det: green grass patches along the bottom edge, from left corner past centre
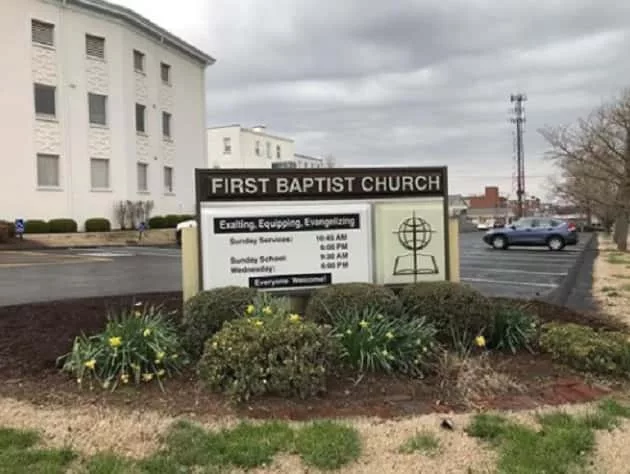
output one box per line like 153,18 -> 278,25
0,421 -> 361,474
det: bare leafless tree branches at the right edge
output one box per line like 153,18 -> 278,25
540,90 -> 630,251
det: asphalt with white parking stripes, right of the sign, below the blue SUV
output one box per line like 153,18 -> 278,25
460,232 -> 588,298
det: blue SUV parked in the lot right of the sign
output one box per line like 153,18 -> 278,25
482,217 -> 579,250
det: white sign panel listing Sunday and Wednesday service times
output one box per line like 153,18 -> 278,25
200,203 -> 372,291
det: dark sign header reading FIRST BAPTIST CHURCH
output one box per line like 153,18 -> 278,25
195,167 -> 448,202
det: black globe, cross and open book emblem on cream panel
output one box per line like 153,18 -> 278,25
393,211 -> 439,281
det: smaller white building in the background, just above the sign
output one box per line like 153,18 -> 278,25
207,124 -> 324,168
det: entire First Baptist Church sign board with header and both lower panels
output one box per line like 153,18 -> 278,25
195,167 -> 449,292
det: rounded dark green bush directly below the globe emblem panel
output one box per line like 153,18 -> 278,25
399,281 -> 495,353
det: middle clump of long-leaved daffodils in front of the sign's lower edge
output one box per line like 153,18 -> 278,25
332,307 -> 436,376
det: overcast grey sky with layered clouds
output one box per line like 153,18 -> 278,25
115,0 -> 630,197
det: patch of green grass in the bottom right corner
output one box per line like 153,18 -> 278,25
466,400 -> 630,474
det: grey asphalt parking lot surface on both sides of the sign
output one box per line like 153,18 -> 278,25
0,232 -> 586,306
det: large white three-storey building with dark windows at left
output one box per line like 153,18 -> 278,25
0,0 -> 215,227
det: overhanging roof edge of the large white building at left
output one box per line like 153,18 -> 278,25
64,0 -> 216,66
